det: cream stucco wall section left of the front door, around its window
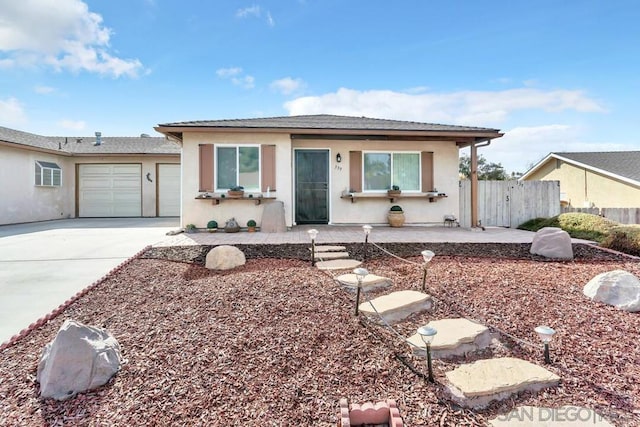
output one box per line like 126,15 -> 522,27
182,132 -> 293,228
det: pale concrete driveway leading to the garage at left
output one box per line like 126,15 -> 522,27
0,218 -> 179,343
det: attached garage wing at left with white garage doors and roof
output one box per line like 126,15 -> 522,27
0,127 -> 180,224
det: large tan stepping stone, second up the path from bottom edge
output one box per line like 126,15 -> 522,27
446,357 -> 560,409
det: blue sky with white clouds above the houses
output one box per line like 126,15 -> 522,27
0,0 -> 640,172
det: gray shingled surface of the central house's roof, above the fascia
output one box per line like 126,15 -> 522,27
159,114 -> 498,133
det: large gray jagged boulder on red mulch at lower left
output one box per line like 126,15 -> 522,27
36,320 -> 122,400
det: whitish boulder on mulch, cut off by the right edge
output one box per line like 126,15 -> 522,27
582,270 -> 640,312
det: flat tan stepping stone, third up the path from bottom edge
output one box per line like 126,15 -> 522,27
407,319 -> 491,359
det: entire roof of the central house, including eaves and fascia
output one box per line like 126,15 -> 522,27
155,114 -> 502,148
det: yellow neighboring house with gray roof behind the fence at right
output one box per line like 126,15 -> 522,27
520,151 -> 640,208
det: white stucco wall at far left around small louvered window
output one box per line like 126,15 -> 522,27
0,146 -> 75,224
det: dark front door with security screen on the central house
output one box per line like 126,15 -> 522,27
295,150 -> 329,224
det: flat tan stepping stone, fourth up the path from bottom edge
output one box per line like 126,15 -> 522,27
358,291 -> 432,324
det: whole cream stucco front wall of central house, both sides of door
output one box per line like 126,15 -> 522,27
182,132 -> 459,228
